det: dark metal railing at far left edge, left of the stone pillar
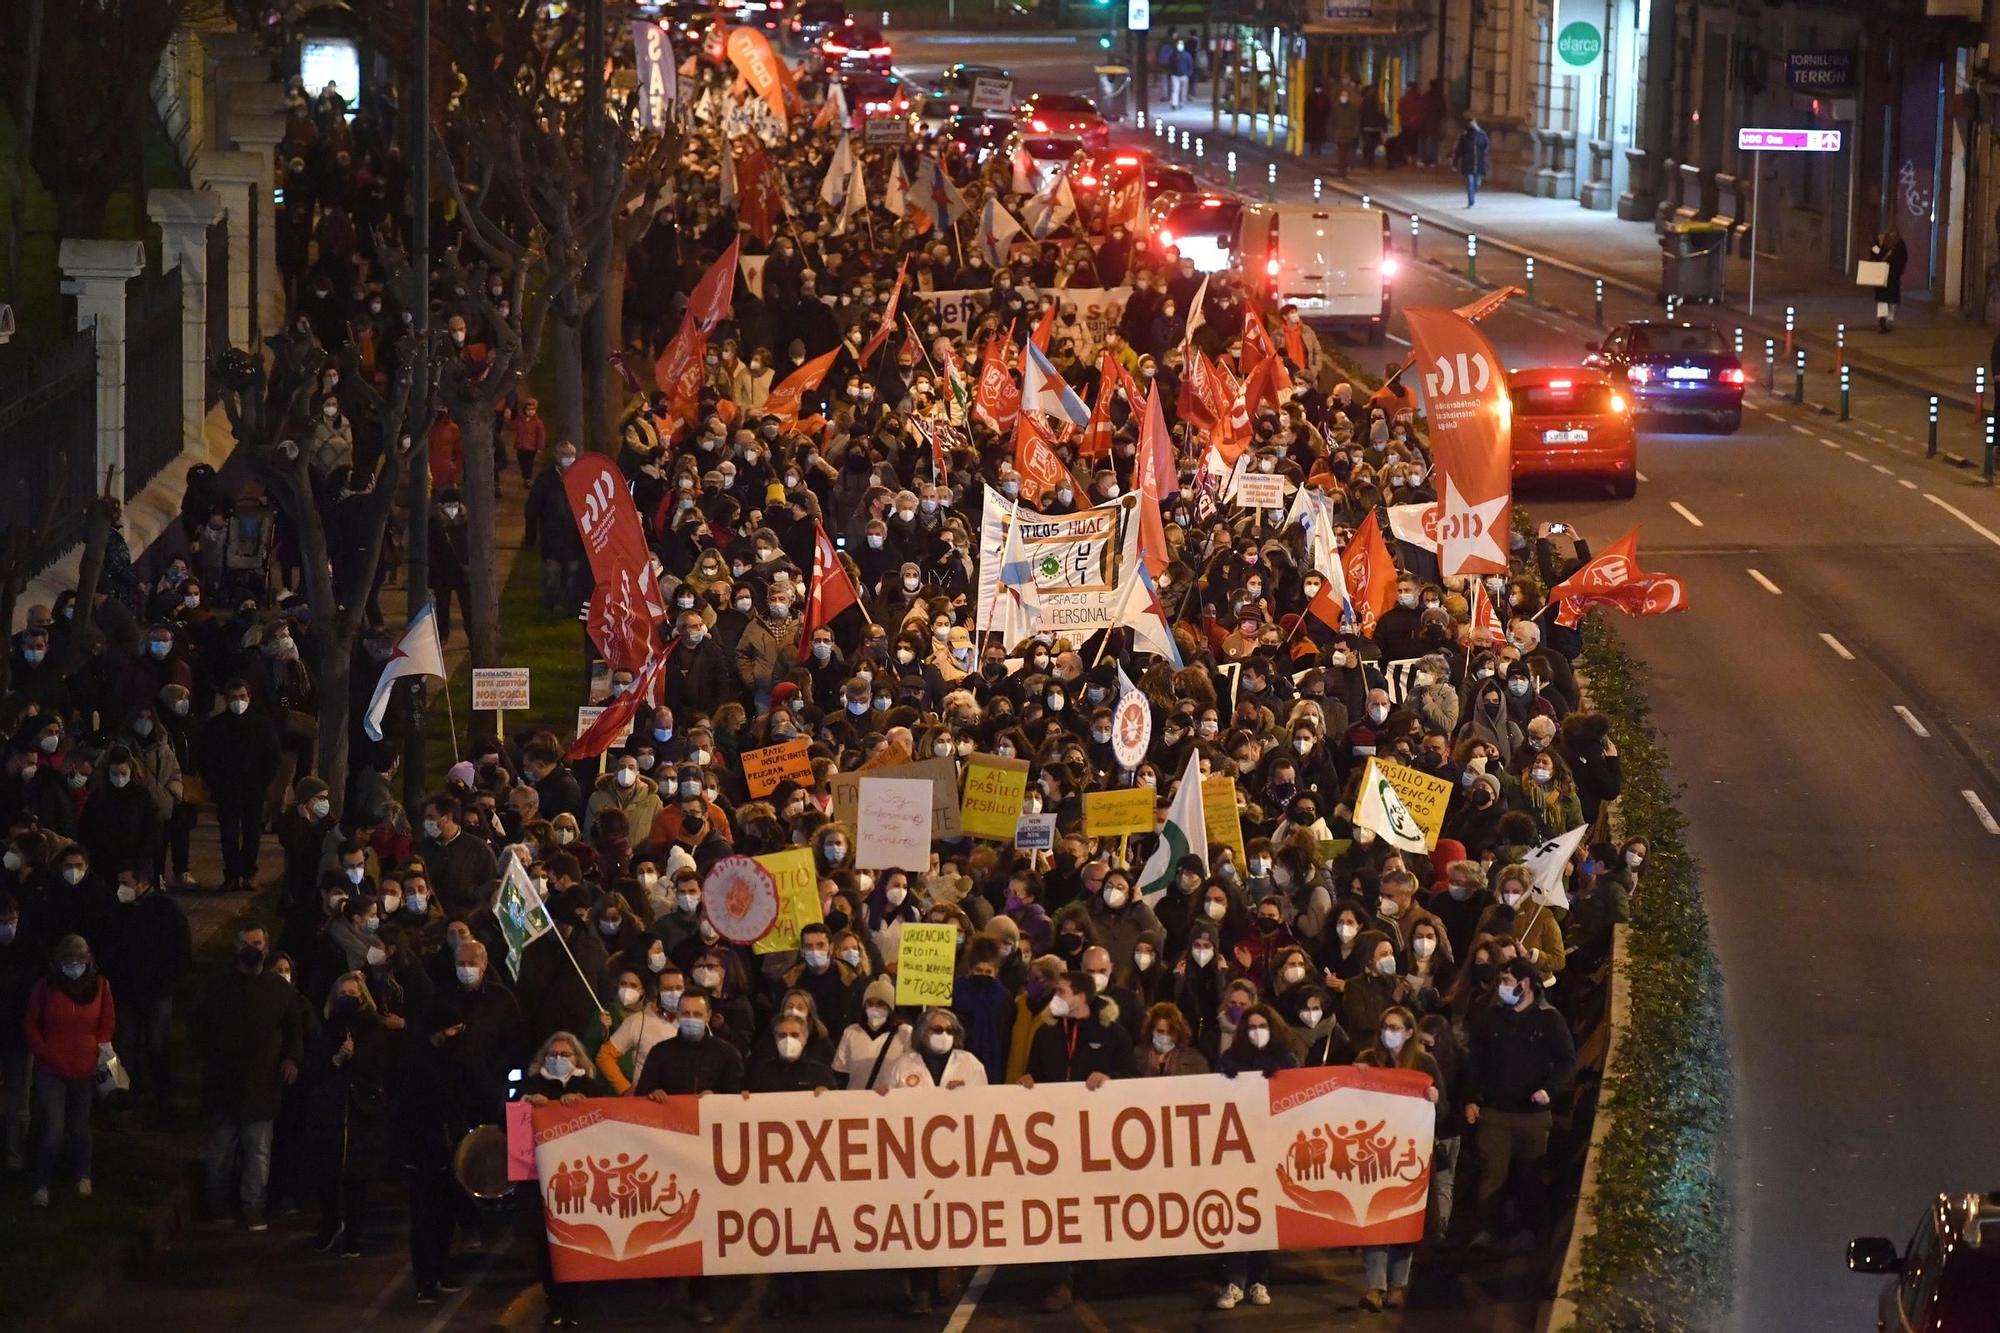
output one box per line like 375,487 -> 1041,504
0,328 -> 100,578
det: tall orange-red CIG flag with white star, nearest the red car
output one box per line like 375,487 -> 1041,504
1404,306 -> 1514,574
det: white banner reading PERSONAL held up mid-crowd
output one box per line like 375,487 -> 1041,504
976,490 -> 1138,648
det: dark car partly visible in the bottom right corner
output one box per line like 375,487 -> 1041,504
1848,1191 -> 2000,1333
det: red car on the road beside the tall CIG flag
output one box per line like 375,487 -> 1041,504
1508,366 -> 1638,498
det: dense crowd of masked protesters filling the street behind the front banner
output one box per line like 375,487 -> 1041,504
0,26 -> 1646,1323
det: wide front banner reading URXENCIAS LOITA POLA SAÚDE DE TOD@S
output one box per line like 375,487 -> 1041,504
532,1049 -> 1434,1281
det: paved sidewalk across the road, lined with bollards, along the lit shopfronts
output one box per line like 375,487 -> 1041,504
1146,102 -> 1994,408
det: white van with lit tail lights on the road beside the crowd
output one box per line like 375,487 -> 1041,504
1234,202 -> 1396,342
